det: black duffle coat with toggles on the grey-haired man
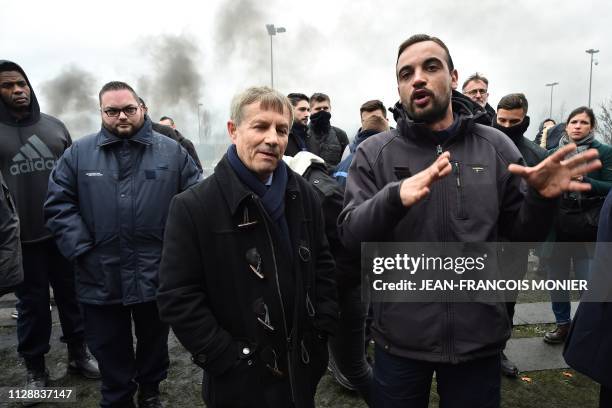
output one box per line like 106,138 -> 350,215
157,155 -> 338,408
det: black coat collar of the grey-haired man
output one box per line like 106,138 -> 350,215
214,153 -> 300,214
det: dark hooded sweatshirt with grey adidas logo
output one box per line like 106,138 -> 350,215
0,60 -> 72,244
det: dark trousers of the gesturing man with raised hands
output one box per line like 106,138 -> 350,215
374,345 -> 501,408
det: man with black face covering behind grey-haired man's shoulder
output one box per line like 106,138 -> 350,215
308,93 -> 348,166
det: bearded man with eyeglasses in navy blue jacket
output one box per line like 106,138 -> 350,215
45,82 -> 200,408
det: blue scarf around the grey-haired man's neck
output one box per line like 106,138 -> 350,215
227,144 -> 291,255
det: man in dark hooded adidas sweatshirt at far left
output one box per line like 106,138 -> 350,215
0,60 -> 100,388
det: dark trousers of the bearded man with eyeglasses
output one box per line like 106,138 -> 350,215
82,302 -> 170,407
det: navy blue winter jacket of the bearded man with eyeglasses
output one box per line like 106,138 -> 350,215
45,119 -> 200,305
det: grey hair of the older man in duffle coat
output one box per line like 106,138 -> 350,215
230,86 -> 293,126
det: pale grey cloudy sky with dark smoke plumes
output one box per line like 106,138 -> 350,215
0,0 -> 612,152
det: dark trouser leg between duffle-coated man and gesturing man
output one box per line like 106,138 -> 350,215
329,286 -> 372,405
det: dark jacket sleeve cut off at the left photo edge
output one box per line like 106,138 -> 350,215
0,173 -> 23,296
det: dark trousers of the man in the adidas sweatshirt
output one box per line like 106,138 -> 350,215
15,239 -> 84,361
